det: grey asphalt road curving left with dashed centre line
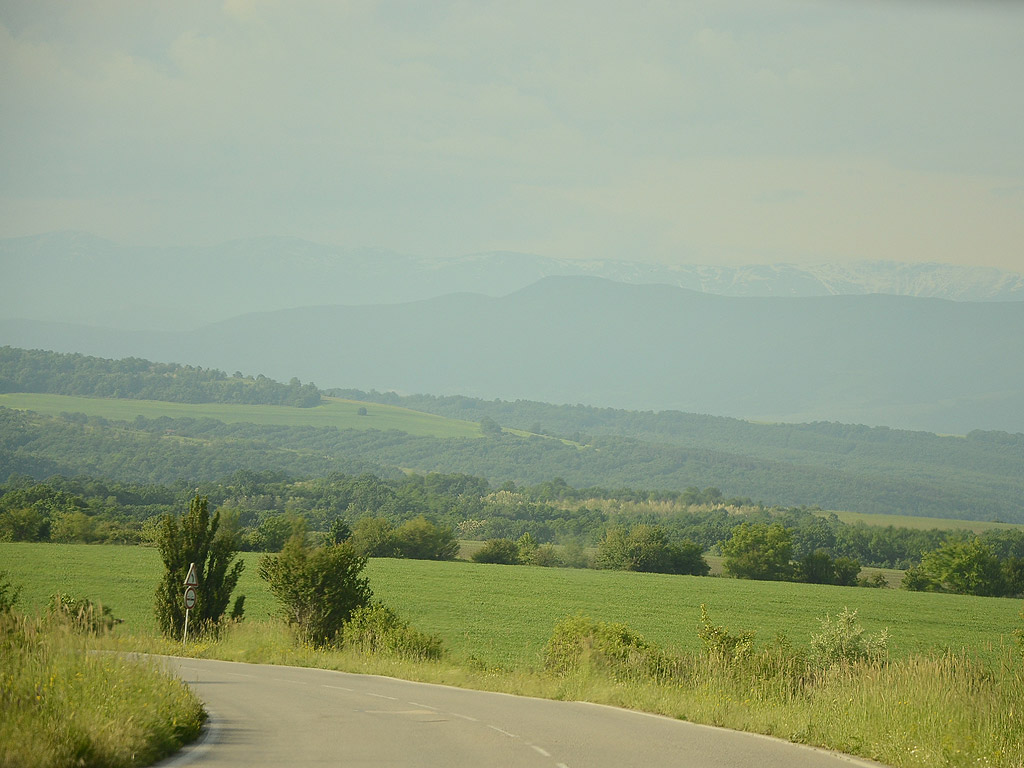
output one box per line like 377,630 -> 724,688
155,658 -> 878,768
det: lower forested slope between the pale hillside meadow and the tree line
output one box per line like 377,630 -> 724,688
0,409 -> 1024,522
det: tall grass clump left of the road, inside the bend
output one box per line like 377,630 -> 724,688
0,611 -> 205,768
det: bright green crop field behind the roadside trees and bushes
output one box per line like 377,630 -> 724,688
0,544 -> 1021,667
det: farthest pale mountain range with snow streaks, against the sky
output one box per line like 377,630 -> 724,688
0,232 -> 1024,331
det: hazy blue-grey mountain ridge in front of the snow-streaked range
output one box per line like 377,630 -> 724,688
0,275 -> 1024,433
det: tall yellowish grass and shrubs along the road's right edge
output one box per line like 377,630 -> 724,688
546,613 -> 1024,768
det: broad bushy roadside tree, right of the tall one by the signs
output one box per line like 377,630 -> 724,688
259,534 -> 373,645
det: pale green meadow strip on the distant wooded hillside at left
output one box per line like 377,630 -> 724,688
0,392 -> 482,437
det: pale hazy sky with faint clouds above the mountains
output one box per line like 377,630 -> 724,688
0,0 -> 1024,271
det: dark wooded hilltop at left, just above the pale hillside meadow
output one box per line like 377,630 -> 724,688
0,346 -> 321,408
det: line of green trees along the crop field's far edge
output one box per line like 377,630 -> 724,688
0,471 -> 1024,595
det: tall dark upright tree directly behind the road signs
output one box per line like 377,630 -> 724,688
154,496 -> 245,638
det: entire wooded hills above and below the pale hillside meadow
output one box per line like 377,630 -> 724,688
0,348 -> 1024,522
